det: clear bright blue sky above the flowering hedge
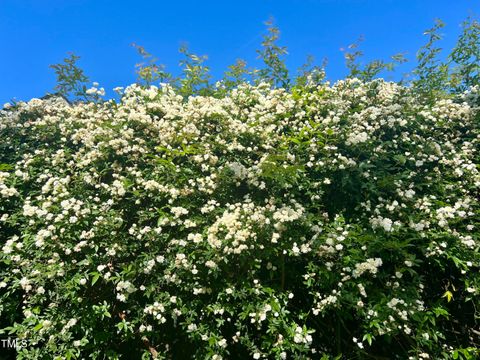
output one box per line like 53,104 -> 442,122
0,0 -> 480,104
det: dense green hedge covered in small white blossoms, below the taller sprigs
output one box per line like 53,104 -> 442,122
0,79 -> 480,360
